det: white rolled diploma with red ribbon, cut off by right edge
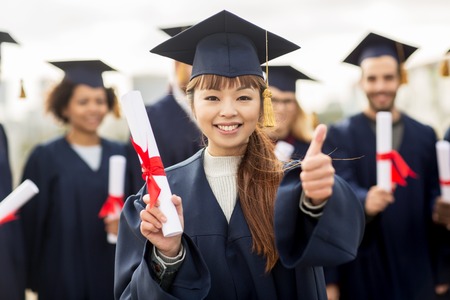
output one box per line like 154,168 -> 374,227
436,141 -> 450,203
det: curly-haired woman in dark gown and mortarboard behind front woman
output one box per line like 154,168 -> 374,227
20,60 -> 129,300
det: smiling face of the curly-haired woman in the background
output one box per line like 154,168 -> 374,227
63,84 -> 109,134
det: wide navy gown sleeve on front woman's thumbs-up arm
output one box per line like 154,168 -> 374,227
275,168 -> 365,268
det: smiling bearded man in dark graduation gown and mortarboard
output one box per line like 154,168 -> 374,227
325,33 -> 448,300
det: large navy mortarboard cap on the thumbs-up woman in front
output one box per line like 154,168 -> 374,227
150,10 -> 300,79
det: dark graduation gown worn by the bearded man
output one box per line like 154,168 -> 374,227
324,113 -> 439,300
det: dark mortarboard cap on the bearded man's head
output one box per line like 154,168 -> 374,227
344,32 -> 418,66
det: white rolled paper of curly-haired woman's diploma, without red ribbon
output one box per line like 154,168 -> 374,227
107,155 -> 126,244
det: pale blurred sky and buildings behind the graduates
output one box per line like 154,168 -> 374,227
0,0 -> 450,190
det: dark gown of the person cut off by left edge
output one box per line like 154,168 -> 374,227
0,124 -> 25,300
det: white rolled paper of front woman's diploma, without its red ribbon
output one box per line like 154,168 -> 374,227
121,91 -> 183,237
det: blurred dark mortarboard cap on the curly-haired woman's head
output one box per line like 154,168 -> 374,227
50,60 -> 116,87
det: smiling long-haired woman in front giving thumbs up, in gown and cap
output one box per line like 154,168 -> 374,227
115,11 -> 364,300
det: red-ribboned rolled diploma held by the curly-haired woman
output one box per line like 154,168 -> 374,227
98,155 -> 126,244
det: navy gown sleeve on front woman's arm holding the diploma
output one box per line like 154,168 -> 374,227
114,186 -> 210,300
